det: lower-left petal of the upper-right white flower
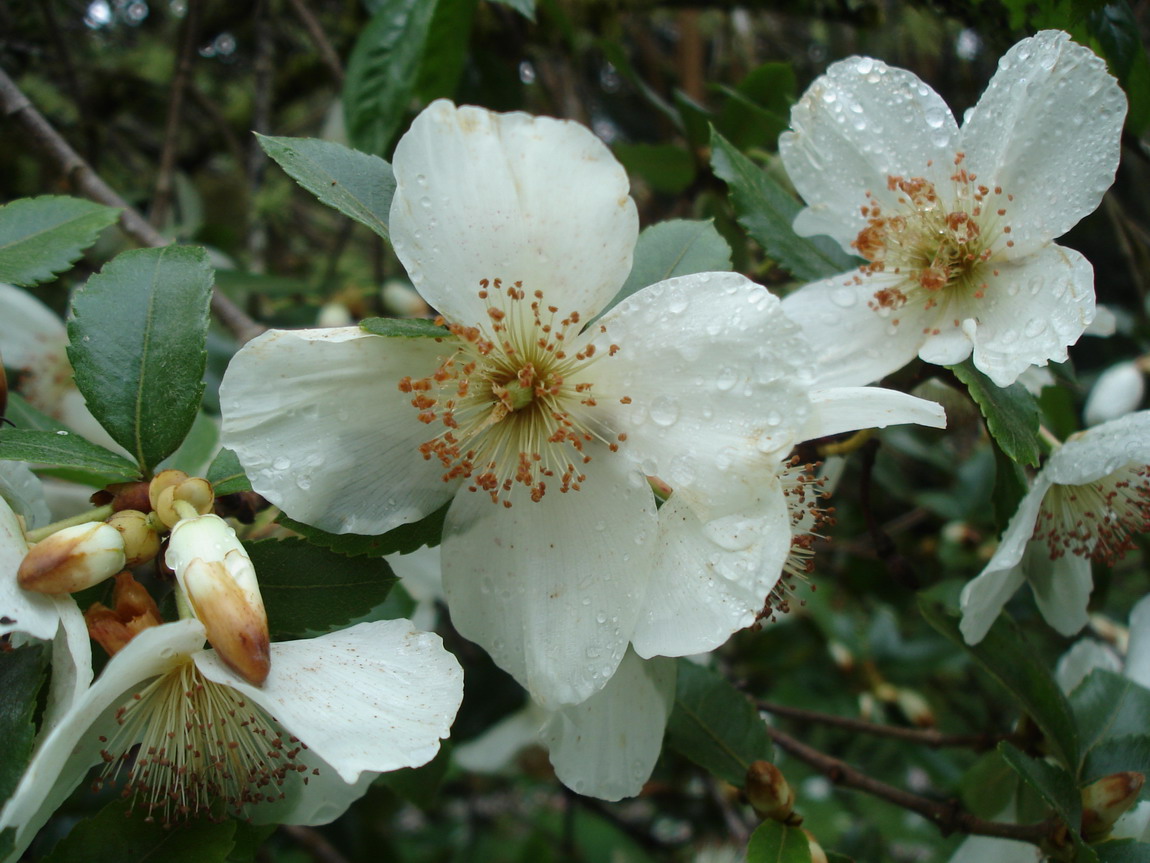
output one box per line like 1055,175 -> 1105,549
783,273 -> 925,387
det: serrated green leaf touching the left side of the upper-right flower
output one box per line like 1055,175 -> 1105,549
711,130 -> 859,282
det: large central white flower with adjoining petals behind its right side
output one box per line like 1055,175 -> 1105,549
221,101 -> 942,709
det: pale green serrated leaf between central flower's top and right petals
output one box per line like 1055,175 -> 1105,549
604,219 -> 730,312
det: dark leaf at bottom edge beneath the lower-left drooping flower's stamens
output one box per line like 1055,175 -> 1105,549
44,800 -> 236,863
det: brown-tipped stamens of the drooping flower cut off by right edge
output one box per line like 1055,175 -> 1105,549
1033,464 -> 1150,564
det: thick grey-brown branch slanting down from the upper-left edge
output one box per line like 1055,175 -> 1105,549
0,63 -> 265,344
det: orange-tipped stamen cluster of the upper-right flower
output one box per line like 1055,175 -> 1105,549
851,153 -> 1014,335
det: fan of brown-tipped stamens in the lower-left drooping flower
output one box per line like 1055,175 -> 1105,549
95,657 -> 314,825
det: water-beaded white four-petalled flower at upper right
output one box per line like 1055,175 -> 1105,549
779,30 -> 1126,387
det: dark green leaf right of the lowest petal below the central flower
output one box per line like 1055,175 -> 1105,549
667,659 -> 773,787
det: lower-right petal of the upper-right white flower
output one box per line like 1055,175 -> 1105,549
971,245 -> 1095,387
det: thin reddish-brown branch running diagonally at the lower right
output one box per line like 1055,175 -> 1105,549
766,725 -> 1063,845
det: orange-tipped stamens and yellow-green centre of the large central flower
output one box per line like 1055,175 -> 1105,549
399,278 -> 630,506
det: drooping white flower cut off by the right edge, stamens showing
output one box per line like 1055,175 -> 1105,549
961,411 -> 1150,644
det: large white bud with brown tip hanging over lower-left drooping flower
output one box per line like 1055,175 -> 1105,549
164,515 -> 271,686
